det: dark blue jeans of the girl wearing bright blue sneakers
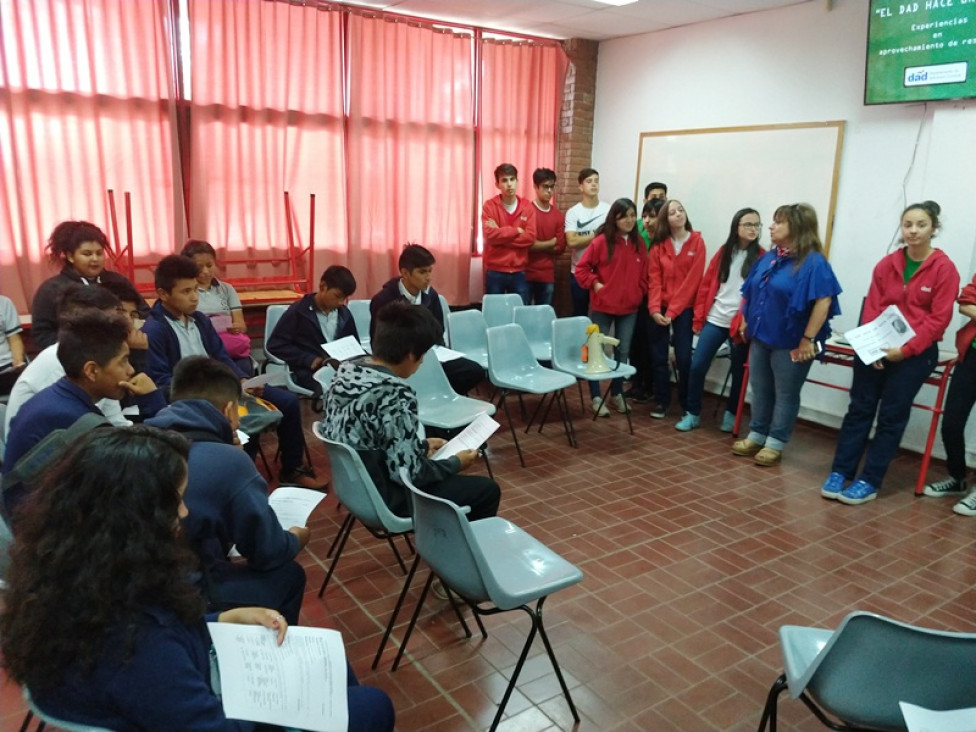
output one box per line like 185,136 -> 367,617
831,344 -> 936,488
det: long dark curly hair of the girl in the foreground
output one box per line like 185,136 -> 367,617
0,426 -> 204,688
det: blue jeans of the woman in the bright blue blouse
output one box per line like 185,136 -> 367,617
749,339 -> 813,450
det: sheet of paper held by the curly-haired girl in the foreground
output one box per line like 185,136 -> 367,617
207,623 -> 349,732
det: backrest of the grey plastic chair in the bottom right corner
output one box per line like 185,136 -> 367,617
790,612 -> 976,729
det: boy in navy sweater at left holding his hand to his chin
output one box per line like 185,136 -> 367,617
3,309 -> 162,516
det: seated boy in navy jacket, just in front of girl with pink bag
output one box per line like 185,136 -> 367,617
144,254 -> 328,490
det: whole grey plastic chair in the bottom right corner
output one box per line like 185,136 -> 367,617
760,612 -> 976,732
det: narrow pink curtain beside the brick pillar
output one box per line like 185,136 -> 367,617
479,39 -> 567,249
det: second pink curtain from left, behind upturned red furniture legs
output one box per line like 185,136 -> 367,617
186,0 -> 348,282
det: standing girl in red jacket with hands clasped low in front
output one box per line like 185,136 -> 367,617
647,199 -> 705,419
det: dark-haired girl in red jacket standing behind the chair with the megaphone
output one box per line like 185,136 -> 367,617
574,198 -> 647,417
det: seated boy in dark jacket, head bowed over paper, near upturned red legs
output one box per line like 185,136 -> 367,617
264,264 -> 359,396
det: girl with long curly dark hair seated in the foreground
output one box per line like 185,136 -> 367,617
0,425 -> 395,732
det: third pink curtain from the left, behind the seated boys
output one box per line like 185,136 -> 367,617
346,12 -> 475,303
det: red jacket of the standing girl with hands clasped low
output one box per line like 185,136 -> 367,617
647,231 -> 705,319
